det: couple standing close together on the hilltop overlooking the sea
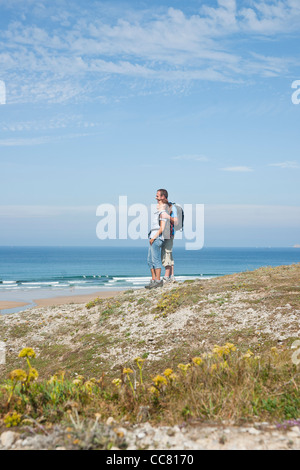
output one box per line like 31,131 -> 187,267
145,189 -> 178,289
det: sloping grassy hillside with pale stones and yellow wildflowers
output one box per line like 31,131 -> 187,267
0,264 -> 300,432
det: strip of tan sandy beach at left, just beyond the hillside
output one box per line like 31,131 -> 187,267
0,291 -> 120,310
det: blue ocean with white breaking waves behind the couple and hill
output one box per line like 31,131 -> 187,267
0,246 -> 300,313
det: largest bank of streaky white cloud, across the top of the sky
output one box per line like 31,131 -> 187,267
0,0 -> 300,103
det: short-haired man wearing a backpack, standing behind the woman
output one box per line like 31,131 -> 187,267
158,189 -> 178,282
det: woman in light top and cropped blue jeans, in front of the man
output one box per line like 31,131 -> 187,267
145,197 -> 169,289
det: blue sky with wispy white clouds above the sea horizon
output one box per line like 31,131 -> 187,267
0,0 -> 300,247
